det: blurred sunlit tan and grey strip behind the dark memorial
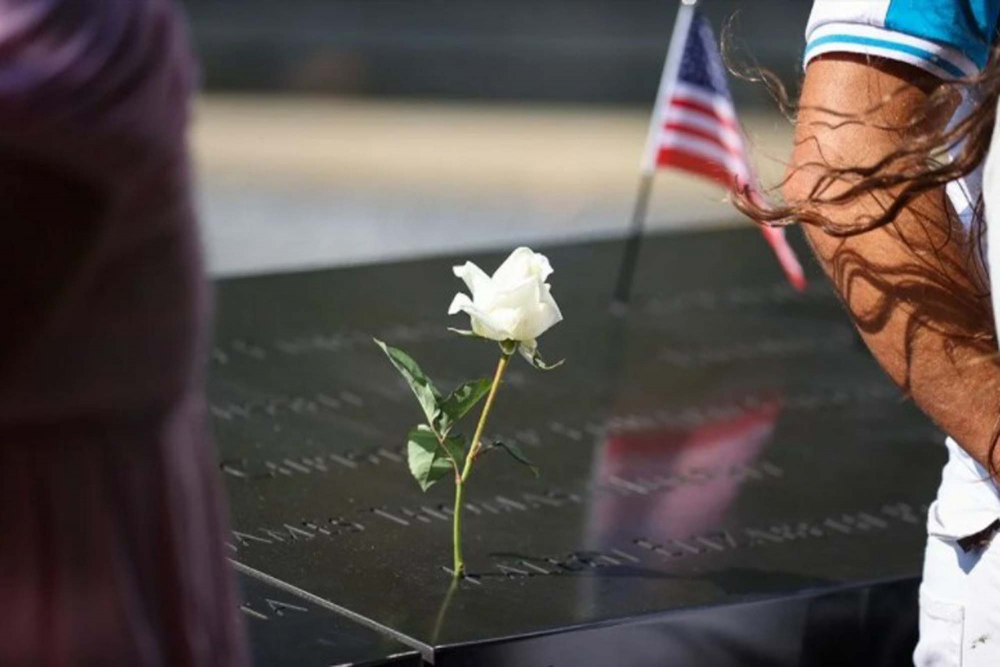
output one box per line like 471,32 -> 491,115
193,96 -> 790,275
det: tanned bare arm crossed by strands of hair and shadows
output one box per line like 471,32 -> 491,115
784,55 -> 1000,467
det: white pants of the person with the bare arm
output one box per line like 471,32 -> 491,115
913,441 -> 1000,667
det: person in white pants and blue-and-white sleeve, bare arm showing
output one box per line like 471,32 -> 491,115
737,0 -> 1000,667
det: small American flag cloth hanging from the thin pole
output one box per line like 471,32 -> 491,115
643,2 -> 805,289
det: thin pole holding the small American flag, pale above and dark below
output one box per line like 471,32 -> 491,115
612,0 -> 698,310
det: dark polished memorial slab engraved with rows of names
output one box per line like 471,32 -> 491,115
210,230 -> 943,666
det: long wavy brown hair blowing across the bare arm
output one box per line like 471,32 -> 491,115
723,36 -> 1000,478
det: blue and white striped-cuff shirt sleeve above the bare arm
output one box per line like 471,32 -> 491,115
805,0 -> 1000,79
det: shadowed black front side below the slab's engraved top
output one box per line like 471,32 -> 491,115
434,581 -> 917,667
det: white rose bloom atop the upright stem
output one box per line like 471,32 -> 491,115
448,248 -> 562,356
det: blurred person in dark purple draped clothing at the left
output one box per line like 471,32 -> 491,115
0,0 -> 247,667
